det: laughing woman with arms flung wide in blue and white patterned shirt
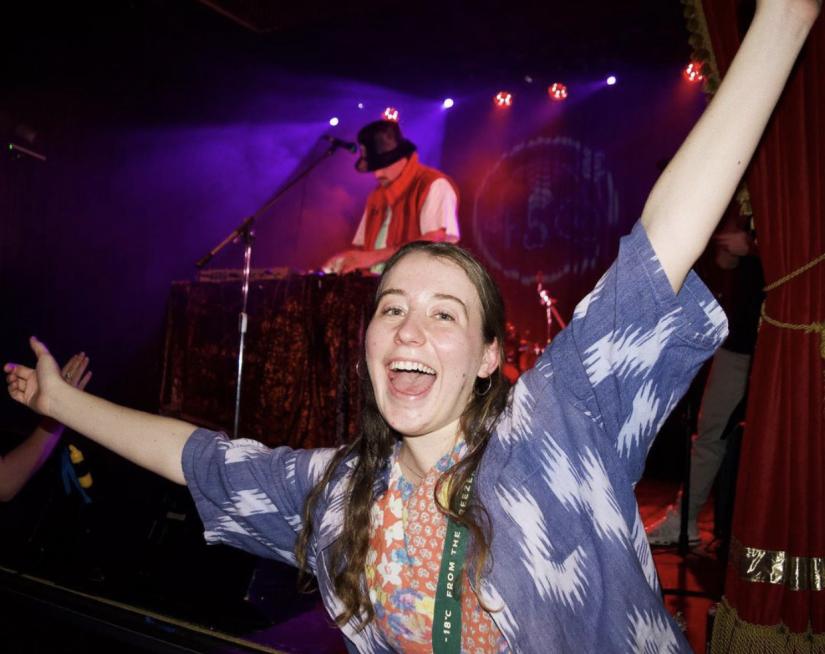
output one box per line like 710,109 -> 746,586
5,0 -> 820,653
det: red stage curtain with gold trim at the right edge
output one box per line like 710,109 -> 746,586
688,0 -> 825,652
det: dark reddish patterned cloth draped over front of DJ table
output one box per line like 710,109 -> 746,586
161,275 -> 378,447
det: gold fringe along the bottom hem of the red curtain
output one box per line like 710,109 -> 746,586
710,597 -> 825,654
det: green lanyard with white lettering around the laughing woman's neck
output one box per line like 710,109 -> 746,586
433,472 -> 475,654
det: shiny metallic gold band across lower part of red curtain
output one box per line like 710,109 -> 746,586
730,539 -> 825,590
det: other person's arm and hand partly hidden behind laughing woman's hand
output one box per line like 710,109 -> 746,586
0,352 -> 92,502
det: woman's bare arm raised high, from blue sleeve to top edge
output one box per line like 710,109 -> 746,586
642,0 -> 822,291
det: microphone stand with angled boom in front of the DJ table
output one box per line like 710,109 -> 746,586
195,143 -> 341,438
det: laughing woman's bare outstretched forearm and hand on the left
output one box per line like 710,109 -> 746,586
3,337 -> 195,484
